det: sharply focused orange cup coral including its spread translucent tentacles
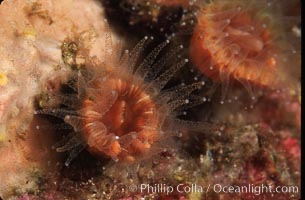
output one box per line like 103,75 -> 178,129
37,36 -> 204,165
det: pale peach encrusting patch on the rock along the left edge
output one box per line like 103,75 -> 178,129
0,0 -> 113,197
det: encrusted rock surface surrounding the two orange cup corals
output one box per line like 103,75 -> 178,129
0,0 -> 301,200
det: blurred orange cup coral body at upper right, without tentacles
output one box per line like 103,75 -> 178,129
190,2 -> 277,87
